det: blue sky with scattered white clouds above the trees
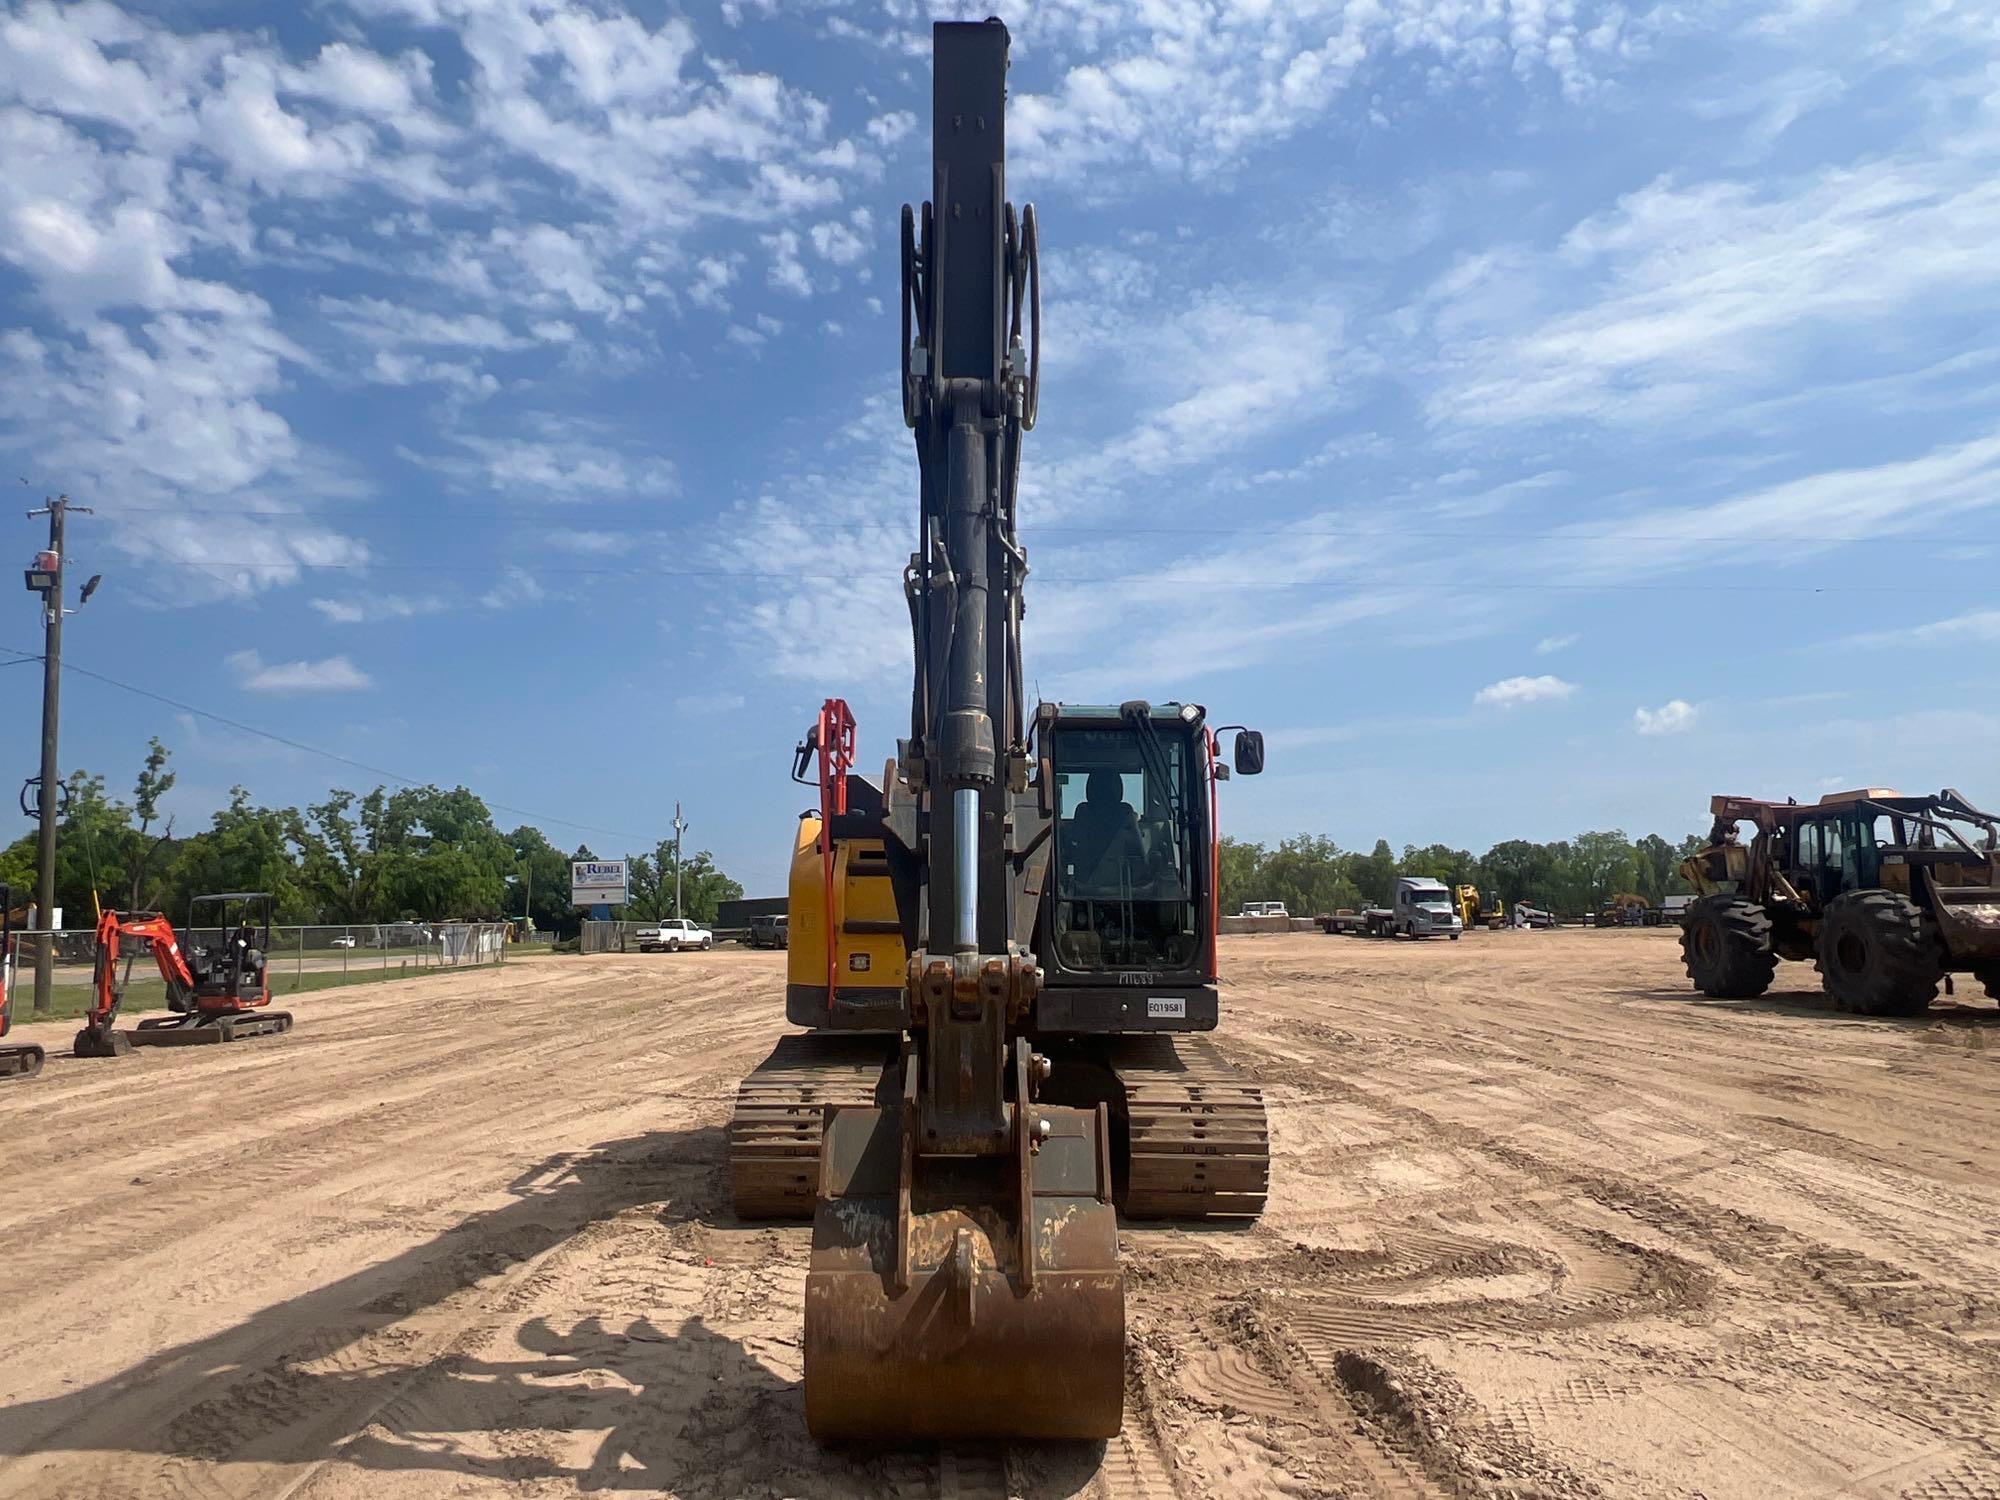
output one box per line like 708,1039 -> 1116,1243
0,0 -> 2000,892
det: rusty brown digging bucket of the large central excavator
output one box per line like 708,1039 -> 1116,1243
806,1074 -> 1124,1442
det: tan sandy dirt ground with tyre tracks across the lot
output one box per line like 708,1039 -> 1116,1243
0,932 -> 2000,1500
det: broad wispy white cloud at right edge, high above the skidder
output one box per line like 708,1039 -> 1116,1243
1430,152 -> 2000,426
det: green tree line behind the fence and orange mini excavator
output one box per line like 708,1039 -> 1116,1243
0,740 -> 742,932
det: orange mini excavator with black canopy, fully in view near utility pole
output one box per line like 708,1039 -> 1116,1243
74,890 -> 292,1058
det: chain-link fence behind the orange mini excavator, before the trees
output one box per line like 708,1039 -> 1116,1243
14,922 -> 508,1020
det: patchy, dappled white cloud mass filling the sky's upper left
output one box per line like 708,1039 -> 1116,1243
0,0 -> 876,588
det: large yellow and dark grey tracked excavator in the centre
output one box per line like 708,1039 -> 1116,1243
728,20 -> 1270,1442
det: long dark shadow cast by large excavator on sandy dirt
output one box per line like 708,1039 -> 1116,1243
0,1126 -> 1102,1500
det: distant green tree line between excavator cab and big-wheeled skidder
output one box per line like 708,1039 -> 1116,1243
1222,828 -> 1706,916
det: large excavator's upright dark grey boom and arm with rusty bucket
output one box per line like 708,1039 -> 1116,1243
804,20 -> 1124,1440
